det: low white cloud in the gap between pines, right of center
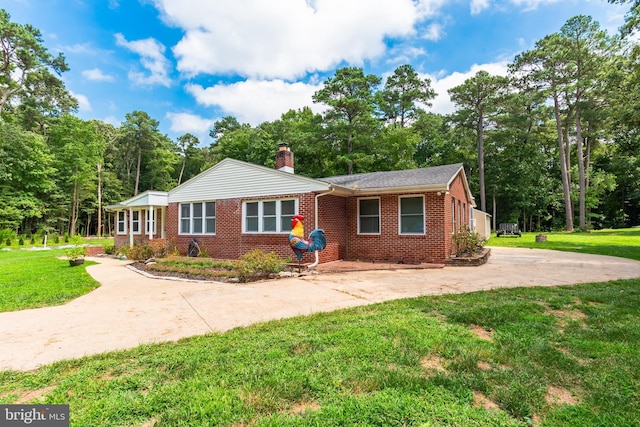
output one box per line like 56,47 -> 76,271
425,61 -> 508,114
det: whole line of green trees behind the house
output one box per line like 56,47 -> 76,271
0,4 -> 640,235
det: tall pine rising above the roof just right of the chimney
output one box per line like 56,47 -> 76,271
313,67 -> 381,174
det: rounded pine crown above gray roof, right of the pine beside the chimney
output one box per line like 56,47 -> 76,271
377,64 -> 436,128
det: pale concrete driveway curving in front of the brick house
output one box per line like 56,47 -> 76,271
0,248 -> 640,370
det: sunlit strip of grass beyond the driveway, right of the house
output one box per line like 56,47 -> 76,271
487,228 -> 640,261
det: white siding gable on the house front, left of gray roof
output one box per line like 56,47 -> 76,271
169,159 -> 329,203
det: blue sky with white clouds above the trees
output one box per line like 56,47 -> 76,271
0,0 -> 628,146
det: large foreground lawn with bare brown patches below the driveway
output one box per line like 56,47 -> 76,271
0,280 -> 640,426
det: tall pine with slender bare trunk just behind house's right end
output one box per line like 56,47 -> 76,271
449,71 -> 509,211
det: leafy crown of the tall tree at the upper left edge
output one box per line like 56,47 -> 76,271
0,9 -> 69,114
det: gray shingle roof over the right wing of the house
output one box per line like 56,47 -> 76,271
318,163 -> 462,190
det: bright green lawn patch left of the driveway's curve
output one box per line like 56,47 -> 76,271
0,249 -> 99,312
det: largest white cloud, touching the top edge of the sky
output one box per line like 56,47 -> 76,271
154,0 -> 428,80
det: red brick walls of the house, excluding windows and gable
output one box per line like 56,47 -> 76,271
116,170 -> 470,264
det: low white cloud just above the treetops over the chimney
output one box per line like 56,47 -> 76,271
186,79 -> 323,126
